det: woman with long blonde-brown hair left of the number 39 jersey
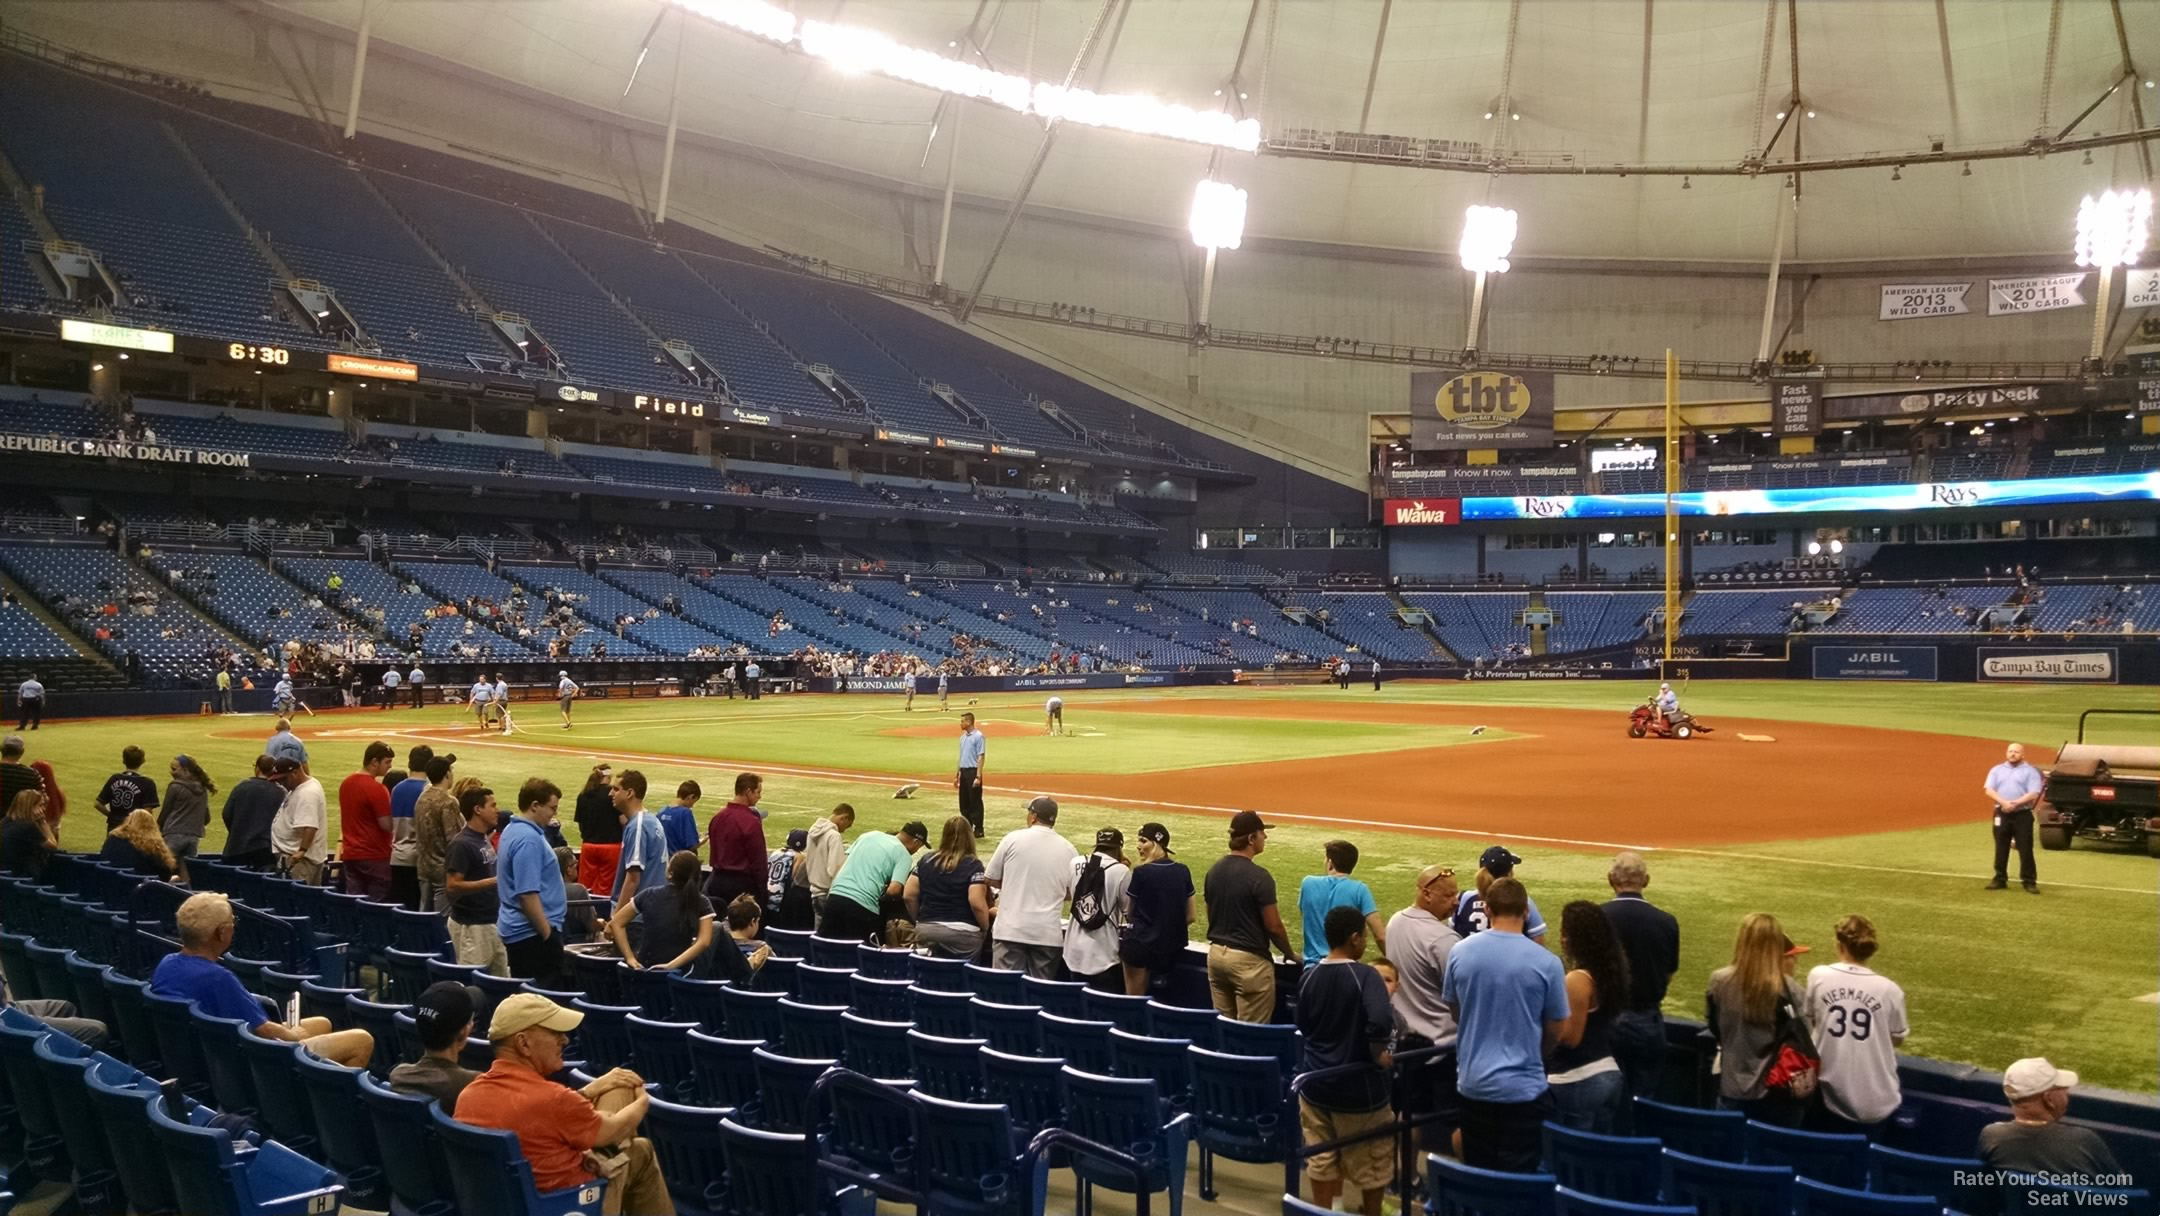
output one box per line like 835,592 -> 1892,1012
1704,911 -> 1806,1127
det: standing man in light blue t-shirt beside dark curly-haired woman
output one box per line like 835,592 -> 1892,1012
1441,879 -> 1568,1173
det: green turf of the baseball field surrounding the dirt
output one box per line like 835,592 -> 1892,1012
30,680 -> 2160,1093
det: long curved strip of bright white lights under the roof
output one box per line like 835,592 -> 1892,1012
674,0 -> 1259,151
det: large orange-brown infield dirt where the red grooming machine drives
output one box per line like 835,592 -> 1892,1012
1054,698 -> 2013,847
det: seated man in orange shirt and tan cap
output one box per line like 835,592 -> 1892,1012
456,994 -> 674,1216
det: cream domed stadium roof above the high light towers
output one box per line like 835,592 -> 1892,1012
281,0 -> 2160,261
